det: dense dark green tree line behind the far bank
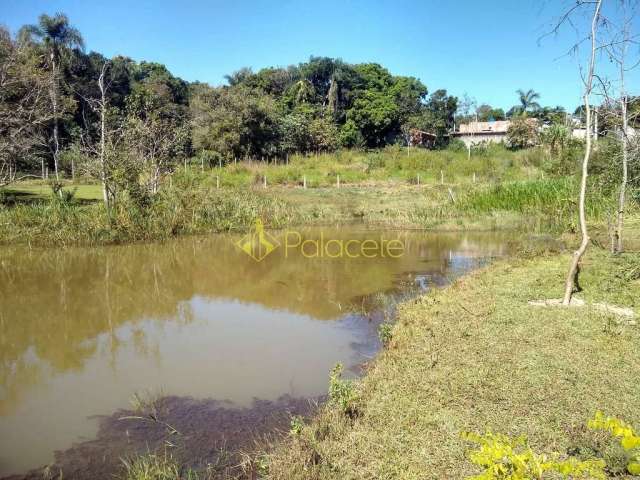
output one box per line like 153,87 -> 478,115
0,13 -> 458,188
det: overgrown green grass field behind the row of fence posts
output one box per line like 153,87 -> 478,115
201,145 -> 544,188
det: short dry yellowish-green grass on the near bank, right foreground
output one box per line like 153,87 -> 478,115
265,248 -> 640,479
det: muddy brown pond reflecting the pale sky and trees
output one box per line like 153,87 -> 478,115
0,227 -> 511,478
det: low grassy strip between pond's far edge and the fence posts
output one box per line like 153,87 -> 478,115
0,175 -> 640,245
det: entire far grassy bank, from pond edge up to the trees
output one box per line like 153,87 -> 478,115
0,146 -> 638,245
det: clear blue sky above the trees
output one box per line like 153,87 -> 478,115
0,0 -> 636,110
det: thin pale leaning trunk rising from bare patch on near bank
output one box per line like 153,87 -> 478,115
562,0 -> 602,305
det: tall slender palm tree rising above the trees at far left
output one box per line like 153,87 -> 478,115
19,13 -> 84,180
